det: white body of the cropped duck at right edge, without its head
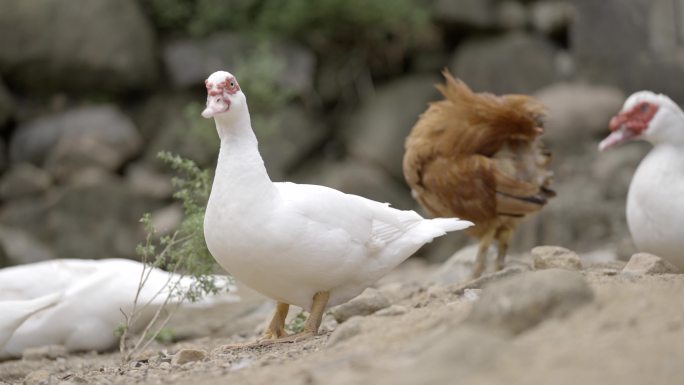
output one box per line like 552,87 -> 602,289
627,145 -> 684,269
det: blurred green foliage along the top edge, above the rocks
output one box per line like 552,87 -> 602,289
141,0 -> 429,50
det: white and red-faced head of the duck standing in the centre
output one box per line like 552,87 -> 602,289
202,71 -> 247,121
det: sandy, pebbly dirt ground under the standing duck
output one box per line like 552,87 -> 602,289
0,255 -> 684,385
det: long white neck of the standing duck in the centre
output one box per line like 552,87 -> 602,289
211,111 -> 276,203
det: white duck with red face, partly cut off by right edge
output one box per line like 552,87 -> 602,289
599,91 -> 684,271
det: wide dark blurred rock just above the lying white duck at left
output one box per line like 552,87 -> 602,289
0,179 -> 164,259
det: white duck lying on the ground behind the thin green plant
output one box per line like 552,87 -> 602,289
0,259 -> 237,359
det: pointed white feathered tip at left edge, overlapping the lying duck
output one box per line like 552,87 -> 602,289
0,293 -> 62,349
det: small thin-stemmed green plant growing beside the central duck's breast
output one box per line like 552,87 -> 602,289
119,152 -> 228,362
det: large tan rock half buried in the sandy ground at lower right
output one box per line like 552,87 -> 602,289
466,269 -> 594,334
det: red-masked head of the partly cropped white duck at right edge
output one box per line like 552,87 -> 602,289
599,91 -> 684,151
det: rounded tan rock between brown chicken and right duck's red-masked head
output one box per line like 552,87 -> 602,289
534,83 -> 626,151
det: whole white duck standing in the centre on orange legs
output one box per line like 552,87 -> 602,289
202,71 -> 472,343
